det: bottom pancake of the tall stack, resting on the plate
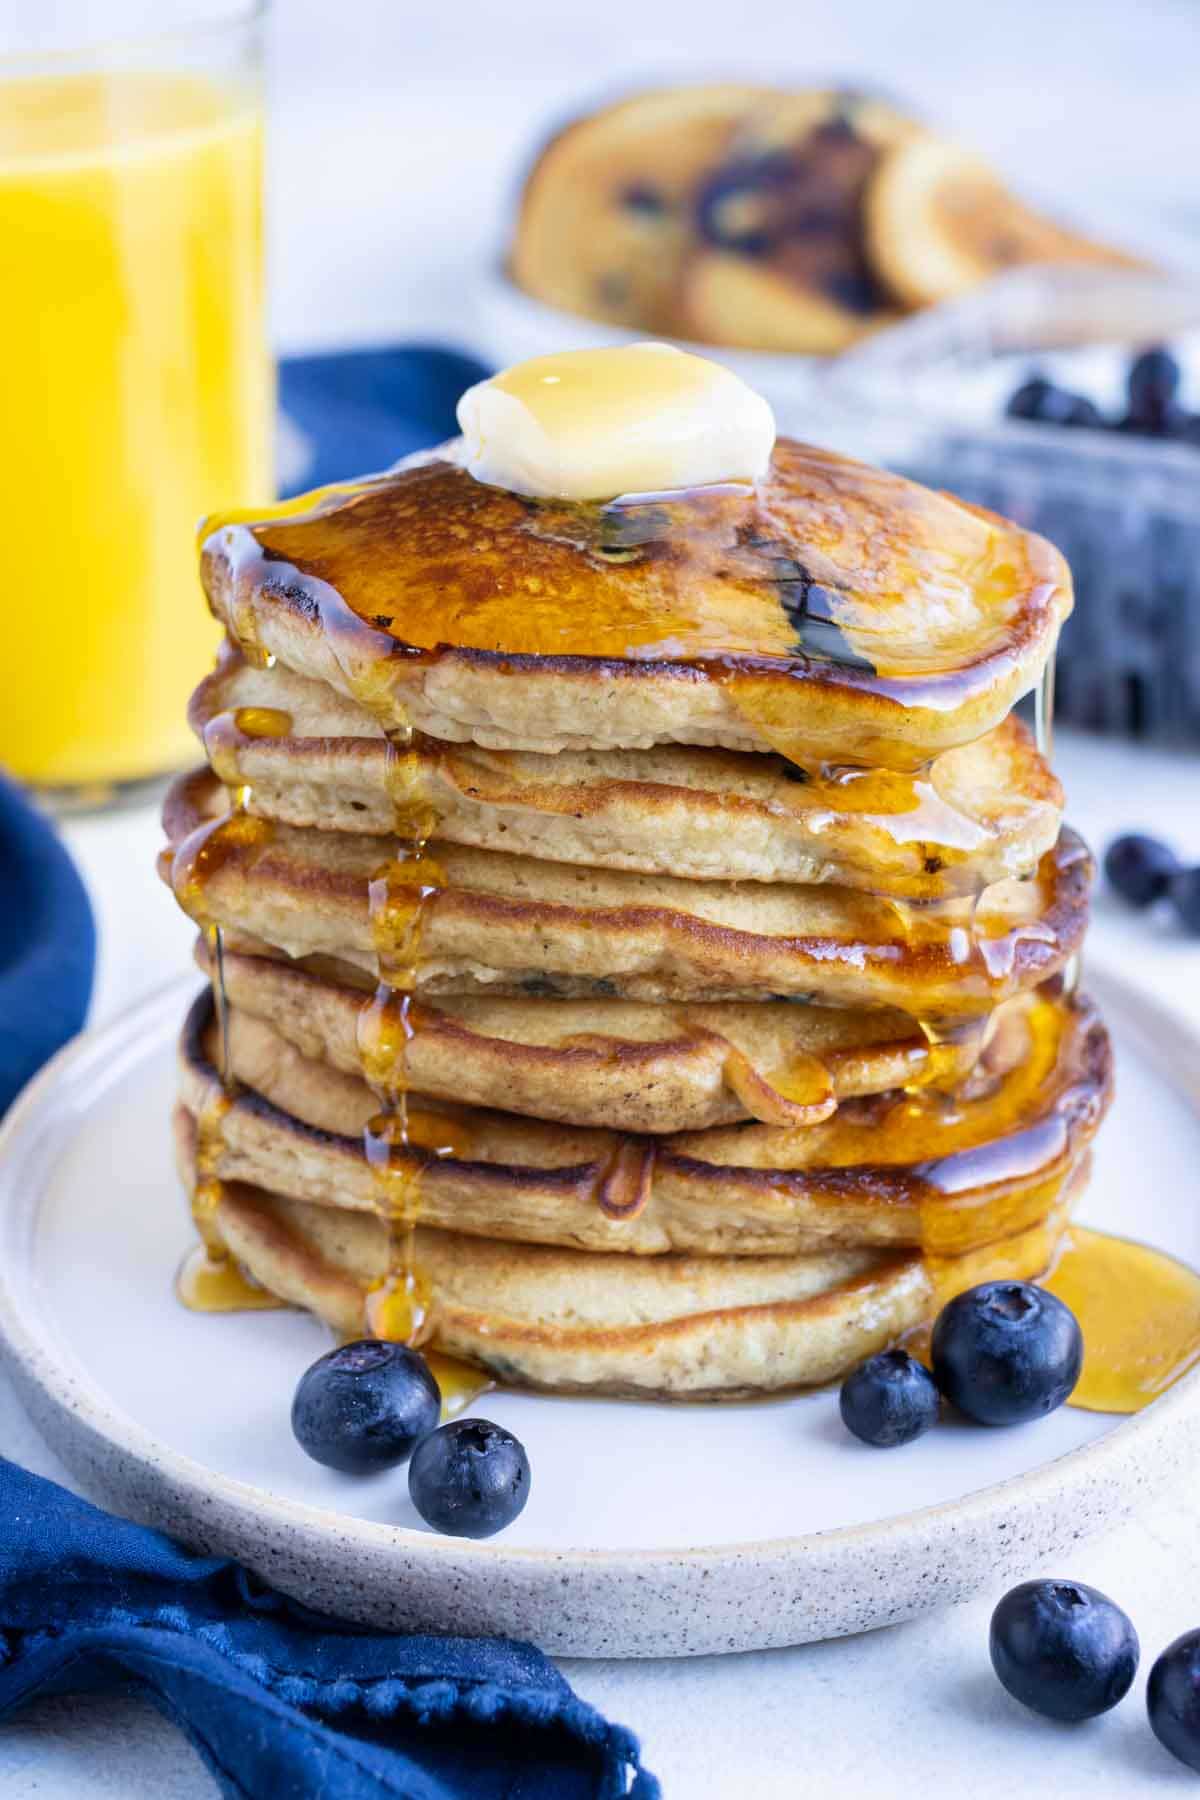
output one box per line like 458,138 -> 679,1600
178,1123 -> 1083,1400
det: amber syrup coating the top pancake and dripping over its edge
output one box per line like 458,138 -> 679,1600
201,439 -> 1067,774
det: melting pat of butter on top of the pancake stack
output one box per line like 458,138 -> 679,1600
459,344 -> 775,500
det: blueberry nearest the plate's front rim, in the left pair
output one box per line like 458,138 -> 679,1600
408,1418 -> 529,1537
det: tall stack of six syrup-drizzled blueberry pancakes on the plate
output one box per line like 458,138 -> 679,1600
164,439 -> 1110,1397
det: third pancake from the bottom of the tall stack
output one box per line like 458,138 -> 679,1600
206,941 -> 993,1132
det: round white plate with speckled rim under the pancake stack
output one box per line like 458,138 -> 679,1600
0,972 -> 1200,1656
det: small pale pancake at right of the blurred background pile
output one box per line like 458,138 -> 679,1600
865,137 -> 1144,306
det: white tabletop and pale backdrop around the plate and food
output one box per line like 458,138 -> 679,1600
0,0 -> 1200,1800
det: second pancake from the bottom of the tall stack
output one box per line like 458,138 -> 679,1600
180,990 -> 1112,1256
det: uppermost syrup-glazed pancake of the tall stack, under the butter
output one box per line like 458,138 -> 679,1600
201,439 -> 1070,769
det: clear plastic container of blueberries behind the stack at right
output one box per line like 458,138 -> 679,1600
802,270 -> 1200,743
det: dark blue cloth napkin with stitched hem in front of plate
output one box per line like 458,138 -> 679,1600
0,1458 -> 658,1800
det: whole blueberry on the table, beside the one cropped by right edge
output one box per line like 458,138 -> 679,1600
990,1580 -> 1141,1719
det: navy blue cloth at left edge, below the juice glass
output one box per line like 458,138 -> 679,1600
0,776 -> 95,1112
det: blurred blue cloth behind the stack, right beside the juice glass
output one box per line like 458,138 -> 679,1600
279,344 -> 489,493
